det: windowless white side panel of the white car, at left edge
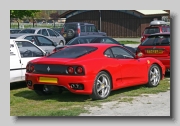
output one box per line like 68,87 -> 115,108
10,40 -> 22,83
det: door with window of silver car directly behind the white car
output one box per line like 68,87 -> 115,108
35,35 -> 55,53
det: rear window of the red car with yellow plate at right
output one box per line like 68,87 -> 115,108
141,35 -> 170,46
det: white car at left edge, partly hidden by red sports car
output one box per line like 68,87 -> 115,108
10,39 -> 46,83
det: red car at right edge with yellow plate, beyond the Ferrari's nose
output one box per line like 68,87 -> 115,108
137,32 -> 171,71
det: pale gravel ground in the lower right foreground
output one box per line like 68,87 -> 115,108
80,91 -> 170,116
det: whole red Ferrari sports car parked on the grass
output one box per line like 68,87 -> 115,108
26,43 -> 165,100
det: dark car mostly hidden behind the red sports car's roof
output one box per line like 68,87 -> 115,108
53,35 -> 136,54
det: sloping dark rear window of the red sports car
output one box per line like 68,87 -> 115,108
47,46 -> 97,58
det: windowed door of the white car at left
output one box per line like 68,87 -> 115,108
16,41 -> 44,80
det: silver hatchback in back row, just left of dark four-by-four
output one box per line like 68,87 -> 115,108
19,28 -> 66,45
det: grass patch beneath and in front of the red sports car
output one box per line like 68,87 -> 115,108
10,79 -> 170,116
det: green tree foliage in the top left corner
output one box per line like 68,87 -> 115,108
10,10 -> 40,19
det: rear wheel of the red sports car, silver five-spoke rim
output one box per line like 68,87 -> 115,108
90,71 -> 112,100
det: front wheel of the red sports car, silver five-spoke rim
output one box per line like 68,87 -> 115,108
147,64 -> 161,87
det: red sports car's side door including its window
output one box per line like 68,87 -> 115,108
111,46 -> 147,86
